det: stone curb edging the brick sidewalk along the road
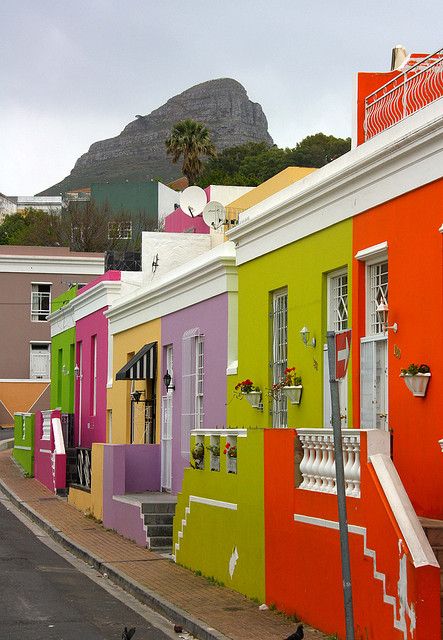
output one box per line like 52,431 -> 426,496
0,478 -> 230,640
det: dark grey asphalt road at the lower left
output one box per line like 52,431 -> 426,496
0,493 -> 181,640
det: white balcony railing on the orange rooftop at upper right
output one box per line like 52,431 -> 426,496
364,49 -> 443,140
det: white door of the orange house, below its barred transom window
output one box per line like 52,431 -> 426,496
360,336 -> 388,430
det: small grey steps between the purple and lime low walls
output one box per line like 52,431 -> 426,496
141,499 -> 176,553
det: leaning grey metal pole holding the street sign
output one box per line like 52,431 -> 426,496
326,331 -> 354,640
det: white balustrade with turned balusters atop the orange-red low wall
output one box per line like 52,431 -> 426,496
297,429 -> 360,498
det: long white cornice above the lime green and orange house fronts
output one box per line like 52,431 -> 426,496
227,100 -> 443,265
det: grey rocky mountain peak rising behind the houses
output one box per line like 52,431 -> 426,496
37,78 -> 273,195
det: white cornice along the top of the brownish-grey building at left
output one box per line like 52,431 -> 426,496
0,254 -> 105,276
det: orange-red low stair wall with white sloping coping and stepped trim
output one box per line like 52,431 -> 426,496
265,429 -> 440,640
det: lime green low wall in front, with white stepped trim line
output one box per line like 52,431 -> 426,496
173,429 -> 265,602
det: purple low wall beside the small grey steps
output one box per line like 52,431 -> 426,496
102,444 -> 160,546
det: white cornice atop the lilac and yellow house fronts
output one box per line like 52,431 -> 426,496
104,242 -> 237,334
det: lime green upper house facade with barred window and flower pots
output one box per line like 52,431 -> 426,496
227,221 -> 352,428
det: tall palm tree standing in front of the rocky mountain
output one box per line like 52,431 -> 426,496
166,119 -> 217,185
